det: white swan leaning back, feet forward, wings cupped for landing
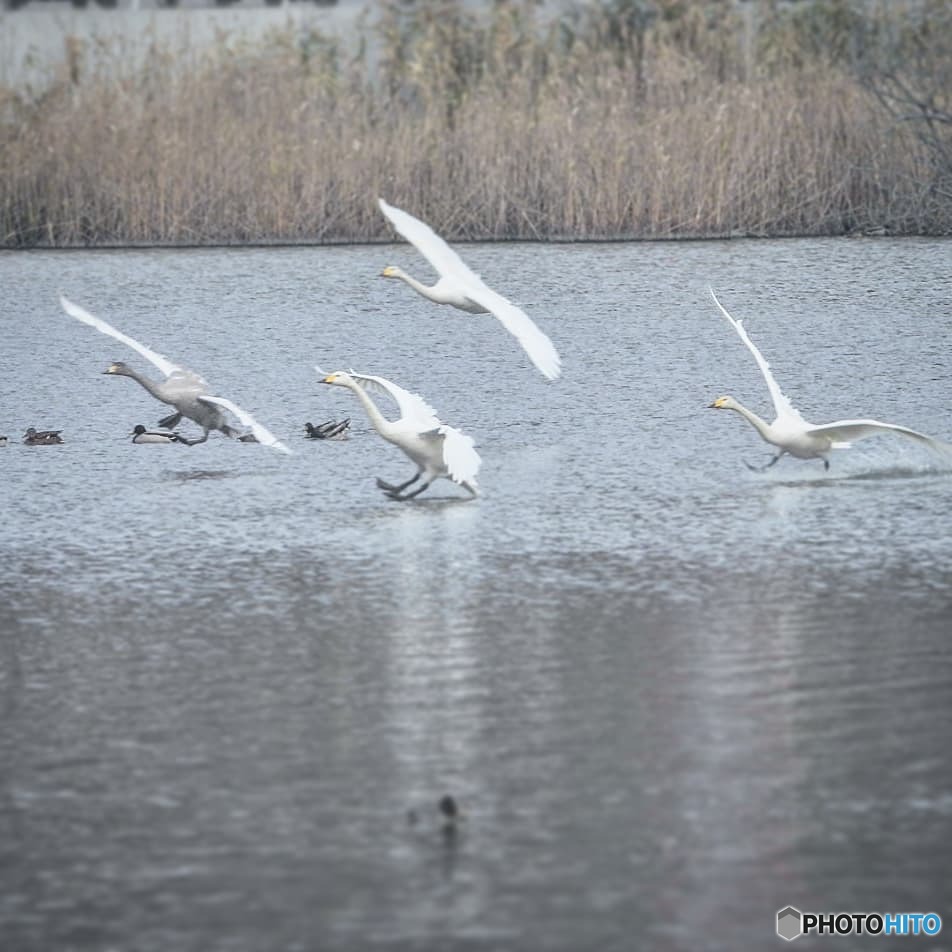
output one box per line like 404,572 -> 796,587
314,367 -> 482,500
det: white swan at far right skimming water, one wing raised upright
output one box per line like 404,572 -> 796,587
708,288 -> 952,471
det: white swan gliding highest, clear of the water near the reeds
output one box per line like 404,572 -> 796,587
377,198 -> 562,380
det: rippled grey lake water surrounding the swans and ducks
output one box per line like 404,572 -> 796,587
0,239 -> 952,952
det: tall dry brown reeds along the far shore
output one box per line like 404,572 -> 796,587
0,0 -> 952,246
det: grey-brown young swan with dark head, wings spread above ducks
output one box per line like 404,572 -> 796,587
60,296 -> 291,453
